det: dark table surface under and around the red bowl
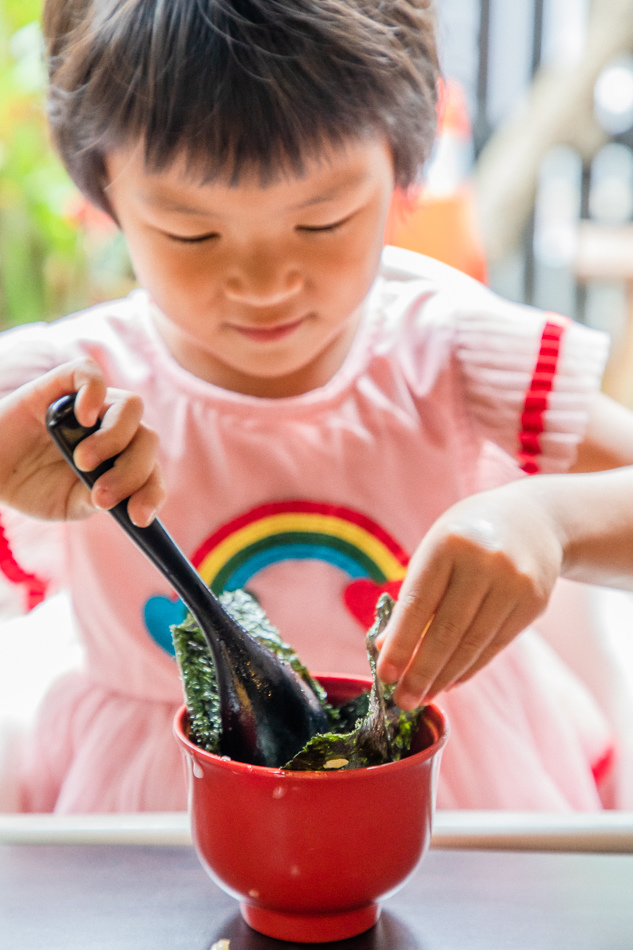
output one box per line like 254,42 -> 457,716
0,845 -> 633,950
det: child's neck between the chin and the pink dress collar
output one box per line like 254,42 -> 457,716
154,308 -> 361,399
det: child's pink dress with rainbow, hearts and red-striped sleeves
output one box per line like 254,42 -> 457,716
0,248 -> 613,812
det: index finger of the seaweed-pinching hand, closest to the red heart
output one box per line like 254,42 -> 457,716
377,558 -> 450,683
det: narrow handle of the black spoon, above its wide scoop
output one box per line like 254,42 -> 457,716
46,396 -> 235,639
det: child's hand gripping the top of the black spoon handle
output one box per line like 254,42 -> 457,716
0,359 -> 165,527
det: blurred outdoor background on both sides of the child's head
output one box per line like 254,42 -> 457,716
0,0 -> 633,405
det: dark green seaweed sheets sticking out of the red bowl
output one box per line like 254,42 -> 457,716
172,590 -> 422,771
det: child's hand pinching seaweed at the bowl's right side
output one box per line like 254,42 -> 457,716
378,488 -> 563,709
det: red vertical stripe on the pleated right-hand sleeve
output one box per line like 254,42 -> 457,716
517,318 -> 567,475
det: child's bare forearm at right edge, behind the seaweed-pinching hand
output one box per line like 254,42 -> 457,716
522,466 -> 633,590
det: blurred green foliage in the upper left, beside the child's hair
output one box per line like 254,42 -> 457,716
0,0 -> 133,329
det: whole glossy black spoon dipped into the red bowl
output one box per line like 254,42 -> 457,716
46,395 -> 329,768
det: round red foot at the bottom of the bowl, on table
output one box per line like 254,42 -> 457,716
240,902 -> 380,943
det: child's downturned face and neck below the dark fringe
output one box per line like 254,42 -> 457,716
107,138 -> 394,397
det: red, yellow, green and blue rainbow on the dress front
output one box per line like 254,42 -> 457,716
192,501 -> 409,594
